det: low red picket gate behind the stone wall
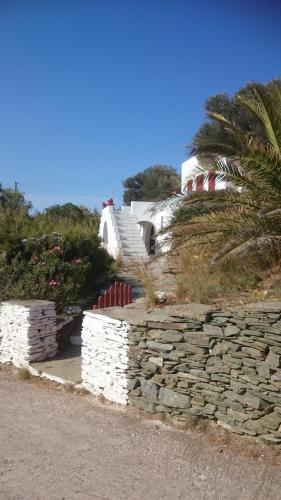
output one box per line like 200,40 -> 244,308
93,281 -> 133,309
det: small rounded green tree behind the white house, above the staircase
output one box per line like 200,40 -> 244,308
123,165 -> 180,205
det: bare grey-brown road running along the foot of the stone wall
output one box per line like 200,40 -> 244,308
0,371 -> 281,500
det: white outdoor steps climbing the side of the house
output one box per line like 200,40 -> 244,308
114,211 -> 148,260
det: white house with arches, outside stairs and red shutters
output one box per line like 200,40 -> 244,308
99,156 -> 222,260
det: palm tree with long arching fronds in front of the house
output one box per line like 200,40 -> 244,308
165,80 -> 281,259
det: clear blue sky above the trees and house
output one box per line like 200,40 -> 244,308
0,0 -> 281,209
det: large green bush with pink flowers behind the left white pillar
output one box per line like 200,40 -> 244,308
0,227 -> 111,310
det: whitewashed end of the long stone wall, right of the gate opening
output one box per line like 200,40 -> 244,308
81,311 -> 129,404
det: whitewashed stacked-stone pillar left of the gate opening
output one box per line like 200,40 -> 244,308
0,300 -> 57,367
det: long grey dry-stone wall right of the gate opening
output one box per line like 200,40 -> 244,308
83,302 -> 281,442
